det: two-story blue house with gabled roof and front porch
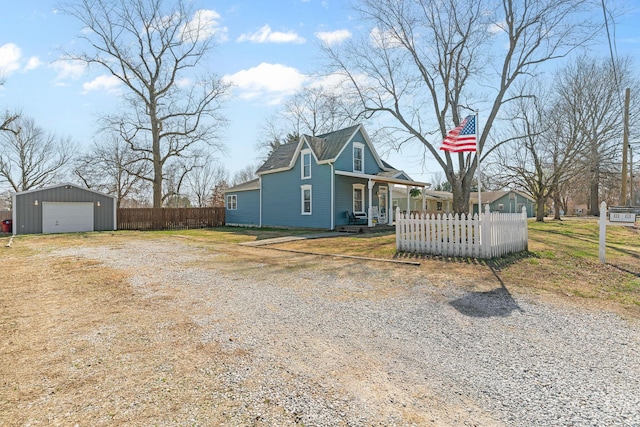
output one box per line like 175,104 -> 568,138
225,125 -> 429,230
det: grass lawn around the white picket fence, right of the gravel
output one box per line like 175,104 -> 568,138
266,219 -> 640,315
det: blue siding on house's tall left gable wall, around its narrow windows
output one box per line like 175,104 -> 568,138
262,152 -> 331,229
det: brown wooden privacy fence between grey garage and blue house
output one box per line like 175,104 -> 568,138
117,207 -> 224,230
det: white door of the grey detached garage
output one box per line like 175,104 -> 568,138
42,202 -> 93,233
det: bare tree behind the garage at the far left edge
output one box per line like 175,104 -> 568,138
0,116 -> 73,191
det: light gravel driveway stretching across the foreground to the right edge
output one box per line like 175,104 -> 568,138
53,238 -> 640,426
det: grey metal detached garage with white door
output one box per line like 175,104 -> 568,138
12,184 -> 116,234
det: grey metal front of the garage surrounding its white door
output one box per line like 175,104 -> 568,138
13,186 -> 115,234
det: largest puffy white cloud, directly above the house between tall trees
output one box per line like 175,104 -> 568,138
223,62 -> 308,104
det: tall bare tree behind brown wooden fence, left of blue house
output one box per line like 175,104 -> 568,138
62,0 -> 228,207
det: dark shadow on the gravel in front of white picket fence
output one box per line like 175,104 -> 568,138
449,266 -> 524,318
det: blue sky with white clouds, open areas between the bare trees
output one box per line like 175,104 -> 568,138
0,0 -> 640,191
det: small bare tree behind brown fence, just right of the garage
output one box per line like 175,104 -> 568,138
73,133 -> 151,207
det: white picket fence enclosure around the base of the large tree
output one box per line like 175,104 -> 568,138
396,205 -> 529,258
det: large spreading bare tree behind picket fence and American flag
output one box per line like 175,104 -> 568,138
325,0 -> 596,212
